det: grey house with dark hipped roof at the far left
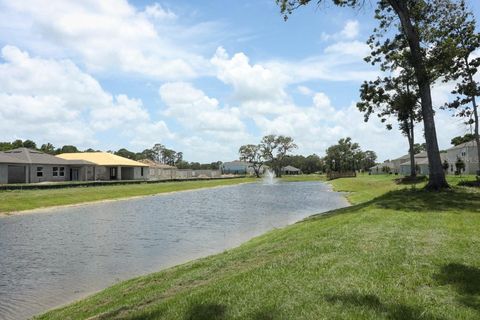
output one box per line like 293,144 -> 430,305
0,148 -> 93,184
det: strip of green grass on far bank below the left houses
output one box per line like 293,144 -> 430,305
0,178 -> 253,214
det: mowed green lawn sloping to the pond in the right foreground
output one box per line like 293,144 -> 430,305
35,176 -> 480,320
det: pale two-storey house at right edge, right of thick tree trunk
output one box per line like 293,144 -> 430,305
446,141 -> 479,174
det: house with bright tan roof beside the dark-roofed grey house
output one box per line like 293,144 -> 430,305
57,152 -> 149,180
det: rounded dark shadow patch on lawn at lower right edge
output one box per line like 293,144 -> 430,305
434,263 -> 480,311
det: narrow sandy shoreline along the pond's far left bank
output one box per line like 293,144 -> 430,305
0,181 -> 255,219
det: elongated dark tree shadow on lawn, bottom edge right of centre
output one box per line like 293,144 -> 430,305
325,293 -> 444,320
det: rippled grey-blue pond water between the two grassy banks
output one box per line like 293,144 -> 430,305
0,182 -> 348,320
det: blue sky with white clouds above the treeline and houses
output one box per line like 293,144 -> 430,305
0,0 -> 480,163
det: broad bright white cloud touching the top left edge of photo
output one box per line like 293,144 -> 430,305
0,0 -> 208,79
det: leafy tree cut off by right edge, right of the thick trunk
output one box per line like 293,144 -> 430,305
431,0 -> 480,170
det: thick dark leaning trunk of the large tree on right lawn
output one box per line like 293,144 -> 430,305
388,0 -> 449,190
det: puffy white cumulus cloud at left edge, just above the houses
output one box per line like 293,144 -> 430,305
0,46 -> 171,146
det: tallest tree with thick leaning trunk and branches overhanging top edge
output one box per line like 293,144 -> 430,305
276,0 -> 449,190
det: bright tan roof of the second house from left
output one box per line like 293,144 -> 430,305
57,152 -> 148,167
